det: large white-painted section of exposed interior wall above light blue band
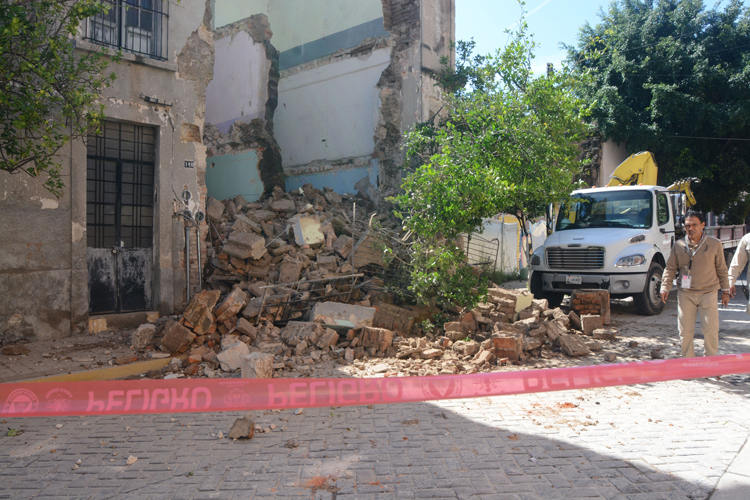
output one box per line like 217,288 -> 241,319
274,48 -> 390,168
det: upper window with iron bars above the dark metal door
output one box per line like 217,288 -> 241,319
83,0 -> 169,60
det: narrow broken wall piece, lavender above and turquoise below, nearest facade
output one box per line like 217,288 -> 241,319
204,14 -> 284,201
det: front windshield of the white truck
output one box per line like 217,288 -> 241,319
556,191 -> 653,231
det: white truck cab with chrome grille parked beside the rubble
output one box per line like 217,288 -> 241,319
530,185 -> 681,316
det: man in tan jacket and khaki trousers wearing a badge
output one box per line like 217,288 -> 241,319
661,211 -> 729,358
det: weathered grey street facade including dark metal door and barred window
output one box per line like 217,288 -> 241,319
0,0 -> 213,343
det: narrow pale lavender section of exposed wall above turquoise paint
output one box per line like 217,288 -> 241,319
206,31 -> 271,132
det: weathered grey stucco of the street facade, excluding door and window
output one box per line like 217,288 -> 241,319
0,0 -> 213,343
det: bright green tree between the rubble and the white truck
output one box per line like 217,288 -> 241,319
397,23 -> 586,303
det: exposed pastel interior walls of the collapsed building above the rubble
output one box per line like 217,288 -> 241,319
205,0 -> 455,201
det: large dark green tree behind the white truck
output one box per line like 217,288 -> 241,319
567,0 -> 750,213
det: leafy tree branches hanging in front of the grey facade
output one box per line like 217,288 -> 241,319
0,0 -> 118,197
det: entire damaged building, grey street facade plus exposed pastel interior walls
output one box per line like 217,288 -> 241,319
0,0 -> 455,344
